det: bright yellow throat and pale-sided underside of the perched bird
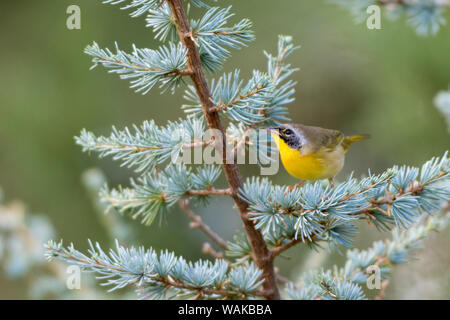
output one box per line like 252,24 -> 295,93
272,135 -> 344,180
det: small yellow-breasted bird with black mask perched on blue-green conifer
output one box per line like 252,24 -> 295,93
265,123 -> 370,187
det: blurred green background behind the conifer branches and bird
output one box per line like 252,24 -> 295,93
0,0 -> 450,299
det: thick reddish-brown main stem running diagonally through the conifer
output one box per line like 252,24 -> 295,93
167,0 -> 280,299
